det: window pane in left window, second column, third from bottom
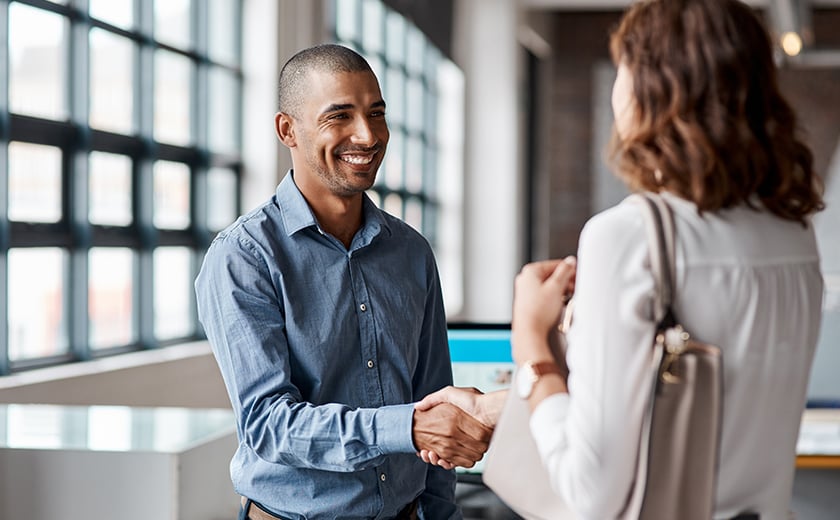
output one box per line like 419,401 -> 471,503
89,28 -> 134,134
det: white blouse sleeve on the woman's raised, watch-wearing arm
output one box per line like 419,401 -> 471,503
530,203 -> 654,519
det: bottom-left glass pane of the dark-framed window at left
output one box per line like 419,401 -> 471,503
9,247 -> 68,361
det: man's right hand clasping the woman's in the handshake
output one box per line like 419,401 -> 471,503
412,403 -> 493,468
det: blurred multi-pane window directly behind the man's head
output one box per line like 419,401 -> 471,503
333,0 -> 464,315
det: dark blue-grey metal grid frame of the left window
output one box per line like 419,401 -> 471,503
0,0 -> 244,375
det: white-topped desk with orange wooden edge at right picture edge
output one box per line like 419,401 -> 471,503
796,408 -> 840,469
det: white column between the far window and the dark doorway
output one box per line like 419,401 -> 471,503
453,0 -> 523,321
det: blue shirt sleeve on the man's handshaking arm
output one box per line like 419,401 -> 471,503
196,237 -> 415,472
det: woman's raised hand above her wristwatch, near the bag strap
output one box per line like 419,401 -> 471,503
511,256 -> 576,365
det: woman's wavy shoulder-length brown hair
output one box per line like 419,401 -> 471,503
610,0 -> 824,224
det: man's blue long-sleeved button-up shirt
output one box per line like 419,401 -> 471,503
195,172 -> 461,520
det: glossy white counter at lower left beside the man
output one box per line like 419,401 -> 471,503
0,404 -> 238,520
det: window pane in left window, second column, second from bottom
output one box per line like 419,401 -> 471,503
88,152 -> 133,226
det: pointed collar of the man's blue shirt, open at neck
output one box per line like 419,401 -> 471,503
276,170 -> 391,245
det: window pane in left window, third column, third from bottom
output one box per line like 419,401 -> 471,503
154,50 -> 192,145
